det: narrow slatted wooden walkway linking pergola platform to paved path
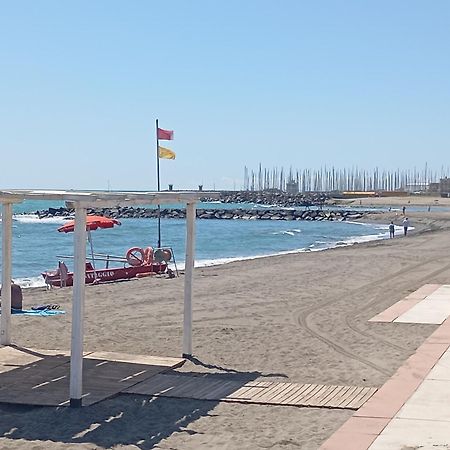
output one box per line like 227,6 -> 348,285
122,374 -> 377,410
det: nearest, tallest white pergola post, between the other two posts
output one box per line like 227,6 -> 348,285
70,205 -> 86,408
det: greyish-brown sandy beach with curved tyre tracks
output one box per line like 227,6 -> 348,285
0,198 -> 450,450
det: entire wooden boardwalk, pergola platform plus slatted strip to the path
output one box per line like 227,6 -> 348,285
0,346 -> 377,409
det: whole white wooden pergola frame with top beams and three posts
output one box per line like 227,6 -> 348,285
0,190 -> 219,407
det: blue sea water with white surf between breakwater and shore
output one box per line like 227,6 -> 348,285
0,201 -> 394,287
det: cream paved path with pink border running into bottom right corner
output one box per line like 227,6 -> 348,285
321,286 -> 450,450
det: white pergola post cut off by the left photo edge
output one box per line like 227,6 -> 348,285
0,203 -> 12,345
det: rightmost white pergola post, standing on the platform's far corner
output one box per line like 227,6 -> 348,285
183,203 -> 195,357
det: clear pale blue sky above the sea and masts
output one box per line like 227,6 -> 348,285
0,0 -> 450,190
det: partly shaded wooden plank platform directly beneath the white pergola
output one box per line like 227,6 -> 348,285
0,346 -> 185,406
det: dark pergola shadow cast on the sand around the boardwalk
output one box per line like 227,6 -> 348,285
0,357 -> 284,450
